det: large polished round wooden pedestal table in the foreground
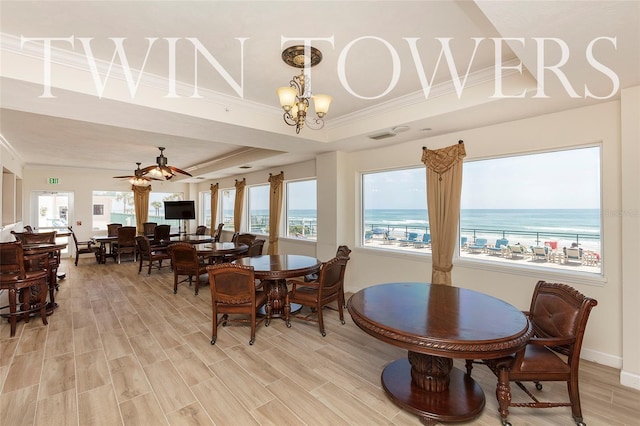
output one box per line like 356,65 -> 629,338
347,283 -> 533,424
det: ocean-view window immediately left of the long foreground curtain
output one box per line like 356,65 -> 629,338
362,167 -> 431,253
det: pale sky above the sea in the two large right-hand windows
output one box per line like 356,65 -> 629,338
363,147 -> 601,209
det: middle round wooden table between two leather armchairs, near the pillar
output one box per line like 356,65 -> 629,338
234,254 -> 322,318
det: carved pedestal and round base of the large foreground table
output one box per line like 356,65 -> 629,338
381,351 -> 485,425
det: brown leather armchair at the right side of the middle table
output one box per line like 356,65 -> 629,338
284,256 -> 349,337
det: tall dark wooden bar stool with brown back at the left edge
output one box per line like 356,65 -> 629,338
0,241 -> 48,337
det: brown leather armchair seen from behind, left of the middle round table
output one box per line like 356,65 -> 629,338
207,263 -> 270,345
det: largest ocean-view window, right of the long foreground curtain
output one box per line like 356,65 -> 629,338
460,147 -> 602,274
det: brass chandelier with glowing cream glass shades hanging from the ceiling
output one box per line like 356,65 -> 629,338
276,46 -> 331,133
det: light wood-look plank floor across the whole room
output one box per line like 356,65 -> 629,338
0,257 -> 640,426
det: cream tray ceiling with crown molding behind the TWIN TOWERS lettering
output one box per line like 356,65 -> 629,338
0,1 -> 640,181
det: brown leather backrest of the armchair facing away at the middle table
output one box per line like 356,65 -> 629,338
207,263 -> 256,305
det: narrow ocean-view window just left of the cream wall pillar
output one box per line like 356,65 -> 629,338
285,180 -> 318,240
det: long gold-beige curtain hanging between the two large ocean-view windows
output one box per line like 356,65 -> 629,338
422,141 -> 466,285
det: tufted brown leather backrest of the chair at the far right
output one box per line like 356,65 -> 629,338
529,281 -> 598,365
